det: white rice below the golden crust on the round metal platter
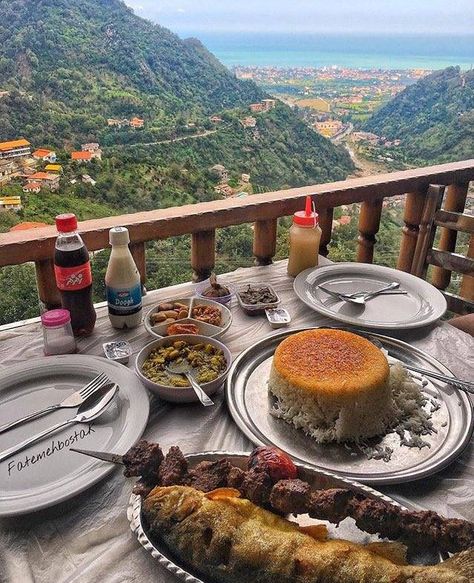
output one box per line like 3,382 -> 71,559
268,363 -> 430,443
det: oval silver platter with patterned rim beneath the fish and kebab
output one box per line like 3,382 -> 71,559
127,451 -> 442,583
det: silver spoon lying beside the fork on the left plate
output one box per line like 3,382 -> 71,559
0,383 -> 119,462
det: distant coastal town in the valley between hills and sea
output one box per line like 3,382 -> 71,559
234,66 -> 430,163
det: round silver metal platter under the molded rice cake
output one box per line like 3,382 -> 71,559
226,328 -> 474,484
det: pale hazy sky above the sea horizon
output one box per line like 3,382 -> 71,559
125,0 -> 474,35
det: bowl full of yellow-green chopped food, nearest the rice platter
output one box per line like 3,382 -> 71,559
135,334 -> 232,403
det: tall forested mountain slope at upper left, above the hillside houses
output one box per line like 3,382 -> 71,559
0,0 -> 262,147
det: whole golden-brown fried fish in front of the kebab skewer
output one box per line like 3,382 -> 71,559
142,486 -> 474,583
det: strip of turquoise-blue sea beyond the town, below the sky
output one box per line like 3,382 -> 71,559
195,32 -> 474,70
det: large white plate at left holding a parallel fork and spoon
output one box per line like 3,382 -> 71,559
0,355 -> 149,516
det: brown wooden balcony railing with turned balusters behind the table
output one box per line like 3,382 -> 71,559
0,160 -> 474,309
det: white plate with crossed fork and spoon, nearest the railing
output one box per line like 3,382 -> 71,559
293,263 -> 447,330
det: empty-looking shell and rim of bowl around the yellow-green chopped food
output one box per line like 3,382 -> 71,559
135,334 -> 232,403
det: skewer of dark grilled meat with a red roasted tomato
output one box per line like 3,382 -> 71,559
74,440 -> 474,553
